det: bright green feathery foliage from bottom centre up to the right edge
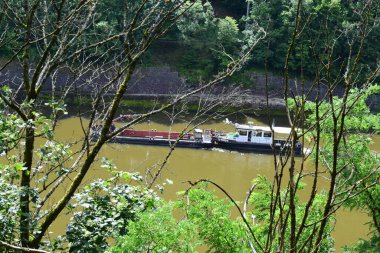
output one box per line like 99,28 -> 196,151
110,75 -> 380,252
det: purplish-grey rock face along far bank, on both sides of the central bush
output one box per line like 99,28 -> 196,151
0,64 -> 380,109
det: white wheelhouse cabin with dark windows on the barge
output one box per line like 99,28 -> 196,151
227,124 -> 273,144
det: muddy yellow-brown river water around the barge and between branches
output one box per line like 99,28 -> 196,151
52,117 -> 380,252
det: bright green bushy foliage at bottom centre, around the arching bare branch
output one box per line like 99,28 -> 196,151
110,177 -> 333,252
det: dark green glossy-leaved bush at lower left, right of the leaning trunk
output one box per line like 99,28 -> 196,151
66,170 -> 158,252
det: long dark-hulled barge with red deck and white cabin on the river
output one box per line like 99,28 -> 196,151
92,116 -> 303,155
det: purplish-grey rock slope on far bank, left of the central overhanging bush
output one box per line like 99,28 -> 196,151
0,64 -> 187,94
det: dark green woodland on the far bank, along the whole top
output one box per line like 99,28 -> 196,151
0,0 -> 380,85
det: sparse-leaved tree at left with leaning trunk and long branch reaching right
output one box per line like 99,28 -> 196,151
0,0 -> 265,252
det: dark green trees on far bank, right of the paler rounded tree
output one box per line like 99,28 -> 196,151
245,0 -> 380,80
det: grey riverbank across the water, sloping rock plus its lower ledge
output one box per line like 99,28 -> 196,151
0,59 -> 380,112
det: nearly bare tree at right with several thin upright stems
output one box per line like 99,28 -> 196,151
256,1 -> 379,252
